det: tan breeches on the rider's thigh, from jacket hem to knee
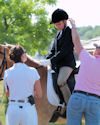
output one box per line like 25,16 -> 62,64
57,66 -> 73,86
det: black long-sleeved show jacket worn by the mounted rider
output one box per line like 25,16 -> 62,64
47,26 -> 76,71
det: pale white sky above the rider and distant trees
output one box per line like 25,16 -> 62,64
48,0 -> 100,27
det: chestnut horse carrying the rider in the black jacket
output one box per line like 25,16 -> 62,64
0,44 -> 76,125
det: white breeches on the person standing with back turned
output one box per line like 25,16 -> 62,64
6,102 -> 38,125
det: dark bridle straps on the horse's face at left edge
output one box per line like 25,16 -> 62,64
0,48 -> 7,81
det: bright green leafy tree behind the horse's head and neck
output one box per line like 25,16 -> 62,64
0,0 -> 56,55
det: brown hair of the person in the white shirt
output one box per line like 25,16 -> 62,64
9,45 -> 25,63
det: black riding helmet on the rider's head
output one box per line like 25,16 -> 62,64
50,9 -> 68,24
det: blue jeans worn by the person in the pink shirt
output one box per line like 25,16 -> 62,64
67,93 -> 100,125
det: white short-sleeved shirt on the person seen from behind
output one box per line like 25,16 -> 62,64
4,63 -> 40,100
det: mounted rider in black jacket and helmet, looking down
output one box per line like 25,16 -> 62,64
42,9 -> 76,104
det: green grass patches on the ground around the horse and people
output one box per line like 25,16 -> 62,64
0,82 -> 85,125
